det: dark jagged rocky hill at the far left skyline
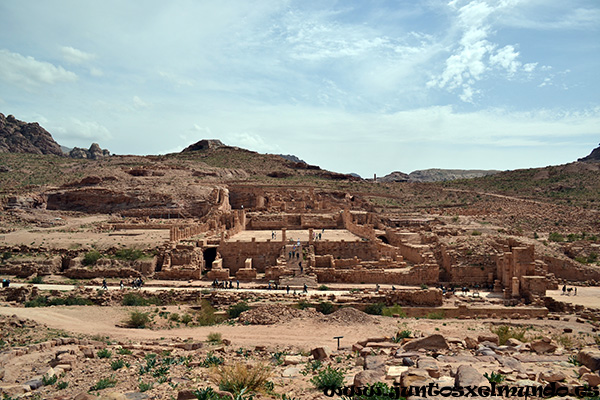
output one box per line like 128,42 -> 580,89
0,113 -> 63,156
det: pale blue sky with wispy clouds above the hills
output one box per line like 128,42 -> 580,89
0,0 -> 600,177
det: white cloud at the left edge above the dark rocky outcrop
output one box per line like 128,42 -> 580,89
0,49 -> 77,89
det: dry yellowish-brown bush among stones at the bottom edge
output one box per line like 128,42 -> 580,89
213,363 -> 271,397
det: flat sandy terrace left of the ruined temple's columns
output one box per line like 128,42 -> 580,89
0,215 -> 169,249
